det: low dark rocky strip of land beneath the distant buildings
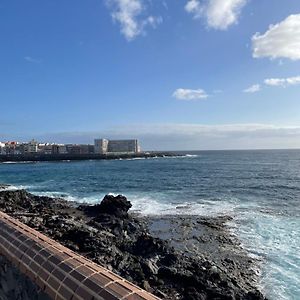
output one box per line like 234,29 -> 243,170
0,152 -> 180,163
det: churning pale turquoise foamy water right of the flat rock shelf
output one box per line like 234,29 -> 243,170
232,209 -> 300,300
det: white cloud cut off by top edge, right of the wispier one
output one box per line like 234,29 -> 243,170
185,0 -> 247,30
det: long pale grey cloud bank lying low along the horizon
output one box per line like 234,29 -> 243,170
38,124 -> 300,150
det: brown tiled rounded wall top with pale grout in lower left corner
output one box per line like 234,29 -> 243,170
0,212 -> 159,300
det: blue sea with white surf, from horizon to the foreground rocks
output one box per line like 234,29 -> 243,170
0,150 -> 300,300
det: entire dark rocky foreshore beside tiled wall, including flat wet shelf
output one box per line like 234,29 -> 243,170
0,185 -> 265,300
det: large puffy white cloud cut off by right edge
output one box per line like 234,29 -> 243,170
252,14 -> 300,60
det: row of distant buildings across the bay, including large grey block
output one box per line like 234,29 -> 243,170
0,139 -> 141,155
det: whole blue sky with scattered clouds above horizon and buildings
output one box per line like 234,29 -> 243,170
0,0 -> 300,150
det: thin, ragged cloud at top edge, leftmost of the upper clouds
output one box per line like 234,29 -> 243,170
107,0 -> 162,41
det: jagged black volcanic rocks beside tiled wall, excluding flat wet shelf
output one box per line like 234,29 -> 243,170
0,190 -> 265,300
